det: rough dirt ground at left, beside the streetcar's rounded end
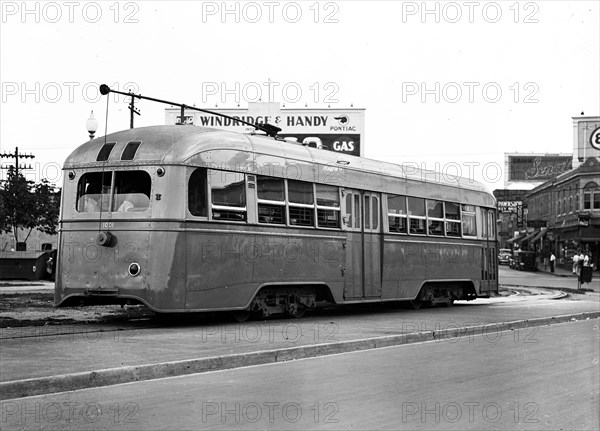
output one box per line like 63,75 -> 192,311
0,292 -> 154,328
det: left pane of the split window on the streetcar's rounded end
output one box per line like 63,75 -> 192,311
76,171 -> 112,213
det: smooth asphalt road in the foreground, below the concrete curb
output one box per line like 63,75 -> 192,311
0,319 -> 600,430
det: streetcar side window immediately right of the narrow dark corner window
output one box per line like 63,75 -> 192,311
208,169 -> 246,221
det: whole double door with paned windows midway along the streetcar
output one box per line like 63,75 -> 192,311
342,189 -> 381,299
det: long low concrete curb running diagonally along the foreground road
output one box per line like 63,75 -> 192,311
0,311 -> 600,400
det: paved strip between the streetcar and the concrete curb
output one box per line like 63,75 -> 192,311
0,288 -> 600,381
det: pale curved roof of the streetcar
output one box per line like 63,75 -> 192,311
63,125 -> 495,206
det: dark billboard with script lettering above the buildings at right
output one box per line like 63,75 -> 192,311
506,154 -> 573,183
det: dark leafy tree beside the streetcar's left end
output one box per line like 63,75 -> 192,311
0,166 -> 60,244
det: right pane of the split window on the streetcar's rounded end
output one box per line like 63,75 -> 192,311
112,171 -> 152,212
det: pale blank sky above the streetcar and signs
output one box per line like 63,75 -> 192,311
0,0 -> 600,190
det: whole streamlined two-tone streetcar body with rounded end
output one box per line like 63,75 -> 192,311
55,126 -> 498,316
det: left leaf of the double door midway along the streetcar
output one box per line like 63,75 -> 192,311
342,189 -> 363,299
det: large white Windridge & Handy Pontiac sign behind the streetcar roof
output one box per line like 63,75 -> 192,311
165,103 -> 365,156
